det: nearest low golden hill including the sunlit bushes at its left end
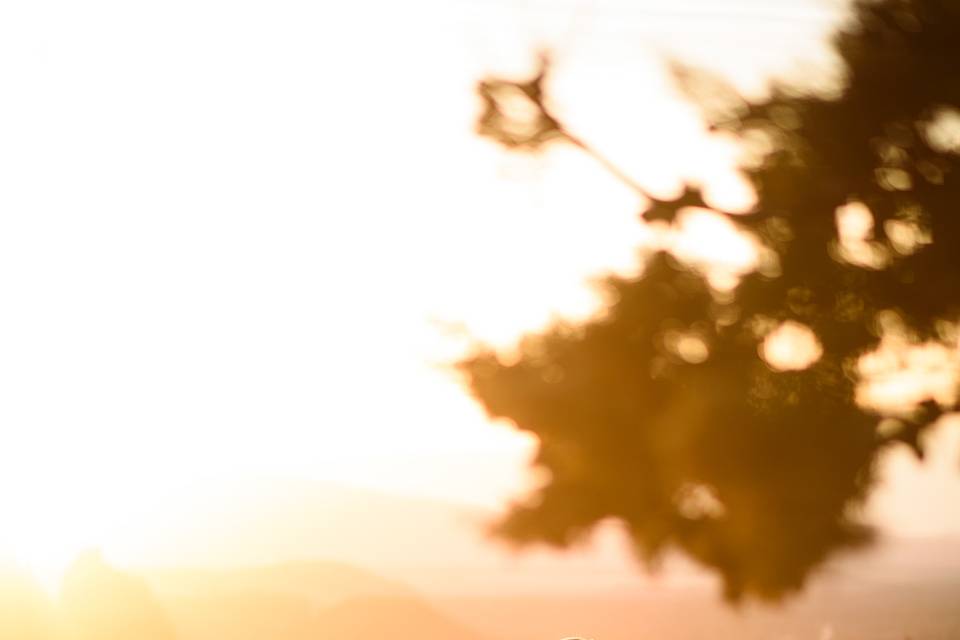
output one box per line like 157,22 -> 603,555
0,552 -> 485,640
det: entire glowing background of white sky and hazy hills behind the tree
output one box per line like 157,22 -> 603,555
0,0 -> 960,640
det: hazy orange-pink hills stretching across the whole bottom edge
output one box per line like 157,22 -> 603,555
0,524 -> 960,640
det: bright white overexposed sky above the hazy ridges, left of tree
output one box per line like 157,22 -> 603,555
0,0 -> 960,584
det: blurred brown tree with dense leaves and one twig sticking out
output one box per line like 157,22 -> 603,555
459,0 -> 960,600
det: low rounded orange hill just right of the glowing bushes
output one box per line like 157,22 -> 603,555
134,561 -> 481,640
